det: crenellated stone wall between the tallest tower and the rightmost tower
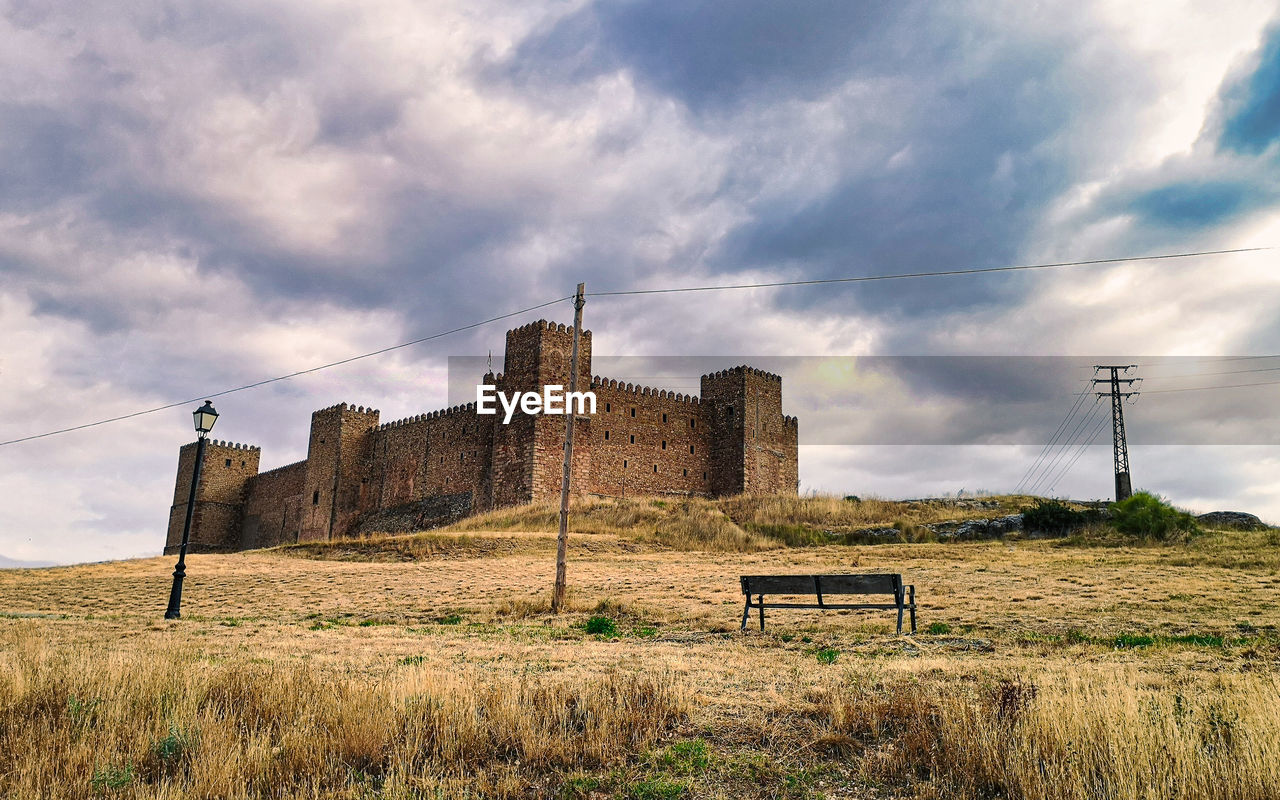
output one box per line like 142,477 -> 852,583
586,378 -> 710,497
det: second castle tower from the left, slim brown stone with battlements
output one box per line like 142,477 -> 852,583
298,403 -> 378,541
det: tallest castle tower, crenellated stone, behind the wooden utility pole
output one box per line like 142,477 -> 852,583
490,320 -> 591,507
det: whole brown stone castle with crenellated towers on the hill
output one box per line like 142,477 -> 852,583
165,320 -> 799,553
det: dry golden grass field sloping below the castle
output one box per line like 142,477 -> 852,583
0,498 -> 1280,800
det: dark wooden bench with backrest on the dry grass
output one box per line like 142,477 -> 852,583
742,573 -> 915,634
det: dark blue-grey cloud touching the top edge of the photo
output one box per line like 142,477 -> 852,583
513,0 -> 922,111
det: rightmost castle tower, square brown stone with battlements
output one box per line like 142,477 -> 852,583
701,366 -> 800,497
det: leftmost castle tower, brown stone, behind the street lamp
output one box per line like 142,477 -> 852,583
164,440 -> 262,554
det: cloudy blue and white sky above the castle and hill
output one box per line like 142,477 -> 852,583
0,0 -> 1280,562
